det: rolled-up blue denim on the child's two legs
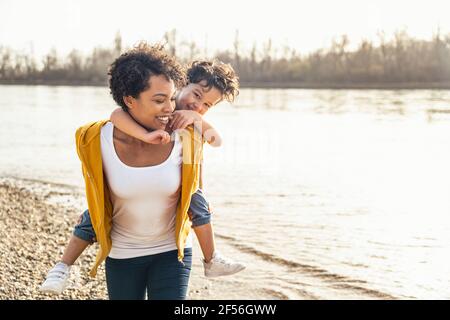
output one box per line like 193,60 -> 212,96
73,189 -> 211,243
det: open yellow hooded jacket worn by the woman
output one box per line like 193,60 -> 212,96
75,120 -> 203,277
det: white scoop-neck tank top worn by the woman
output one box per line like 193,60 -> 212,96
101,122 -> 192,259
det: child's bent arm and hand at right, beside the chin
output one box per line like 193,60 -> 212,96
170,110 -> 222,147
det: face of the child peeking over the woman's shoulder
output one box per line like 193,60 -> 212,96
176,80 -> 222,115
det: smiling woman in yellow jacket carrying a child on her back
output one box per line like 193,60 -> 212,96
76,44 -> 202,299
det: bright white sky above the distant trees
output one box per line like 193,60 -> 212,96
0,0 -> 450,55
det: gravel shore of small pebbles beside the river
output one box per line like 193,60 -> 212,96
0,178 -> 283,300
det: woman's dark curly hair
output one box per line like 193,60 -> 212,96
108,42 -> 186,111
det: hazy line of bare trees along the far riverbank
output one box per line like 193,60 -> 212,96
0,30 -> 450,87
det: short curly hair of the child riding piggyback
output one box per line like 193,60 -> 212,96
187,59 -> 239,102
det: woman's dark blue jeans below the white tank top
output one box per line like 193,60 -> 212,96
105,248 -> 192,300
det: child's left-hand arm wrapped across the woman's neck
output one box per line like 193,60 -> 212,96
110,108 -> 170,144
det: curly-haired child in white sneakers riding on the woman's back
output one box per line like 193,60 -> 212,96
40,60 -> 245,294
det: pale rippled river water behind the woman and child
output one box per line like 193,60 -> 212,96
0,86 -> 450,299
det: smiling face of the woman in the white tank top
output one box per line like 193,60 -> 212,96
124,75 -> 175,130
